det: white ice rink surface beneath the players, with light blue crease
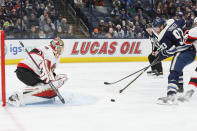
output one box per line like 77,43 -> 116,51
0,62 -> 197,131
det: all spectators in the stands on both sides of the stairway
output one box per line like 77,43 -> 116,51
0,0 -> 197,38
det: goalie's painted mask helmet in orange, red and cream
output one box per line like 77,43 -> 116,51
50,37 -> 64,57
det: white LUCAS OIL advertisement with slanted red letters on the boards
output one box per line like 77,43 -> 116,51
69,39 -> 151,57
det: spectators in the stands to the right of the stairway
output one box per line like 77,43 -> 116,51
75,0 -> 197,38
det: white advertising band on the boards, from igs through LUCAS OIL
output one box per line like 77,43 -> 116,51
5,39 -> 151,59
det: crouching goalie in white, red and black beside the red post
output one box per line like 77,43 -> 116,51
8,37 -> 67,106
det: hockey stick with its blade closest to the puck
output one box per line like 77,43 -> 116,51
119,57 -> 160,93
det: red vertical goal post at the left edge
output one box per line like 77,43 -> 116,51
0,30 -> 6,106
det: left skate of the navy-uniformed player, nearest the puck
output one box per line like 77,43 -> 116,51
157,94 -> 178,105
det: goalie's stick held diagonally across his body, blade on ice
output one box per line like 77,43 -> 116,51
19,41 -> 65,104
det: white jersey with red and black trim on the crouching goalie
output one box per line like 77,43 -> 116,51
17,45 -> 59,76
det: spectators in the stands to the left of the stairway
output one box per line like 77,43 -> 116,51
0,0 -> 72,38
